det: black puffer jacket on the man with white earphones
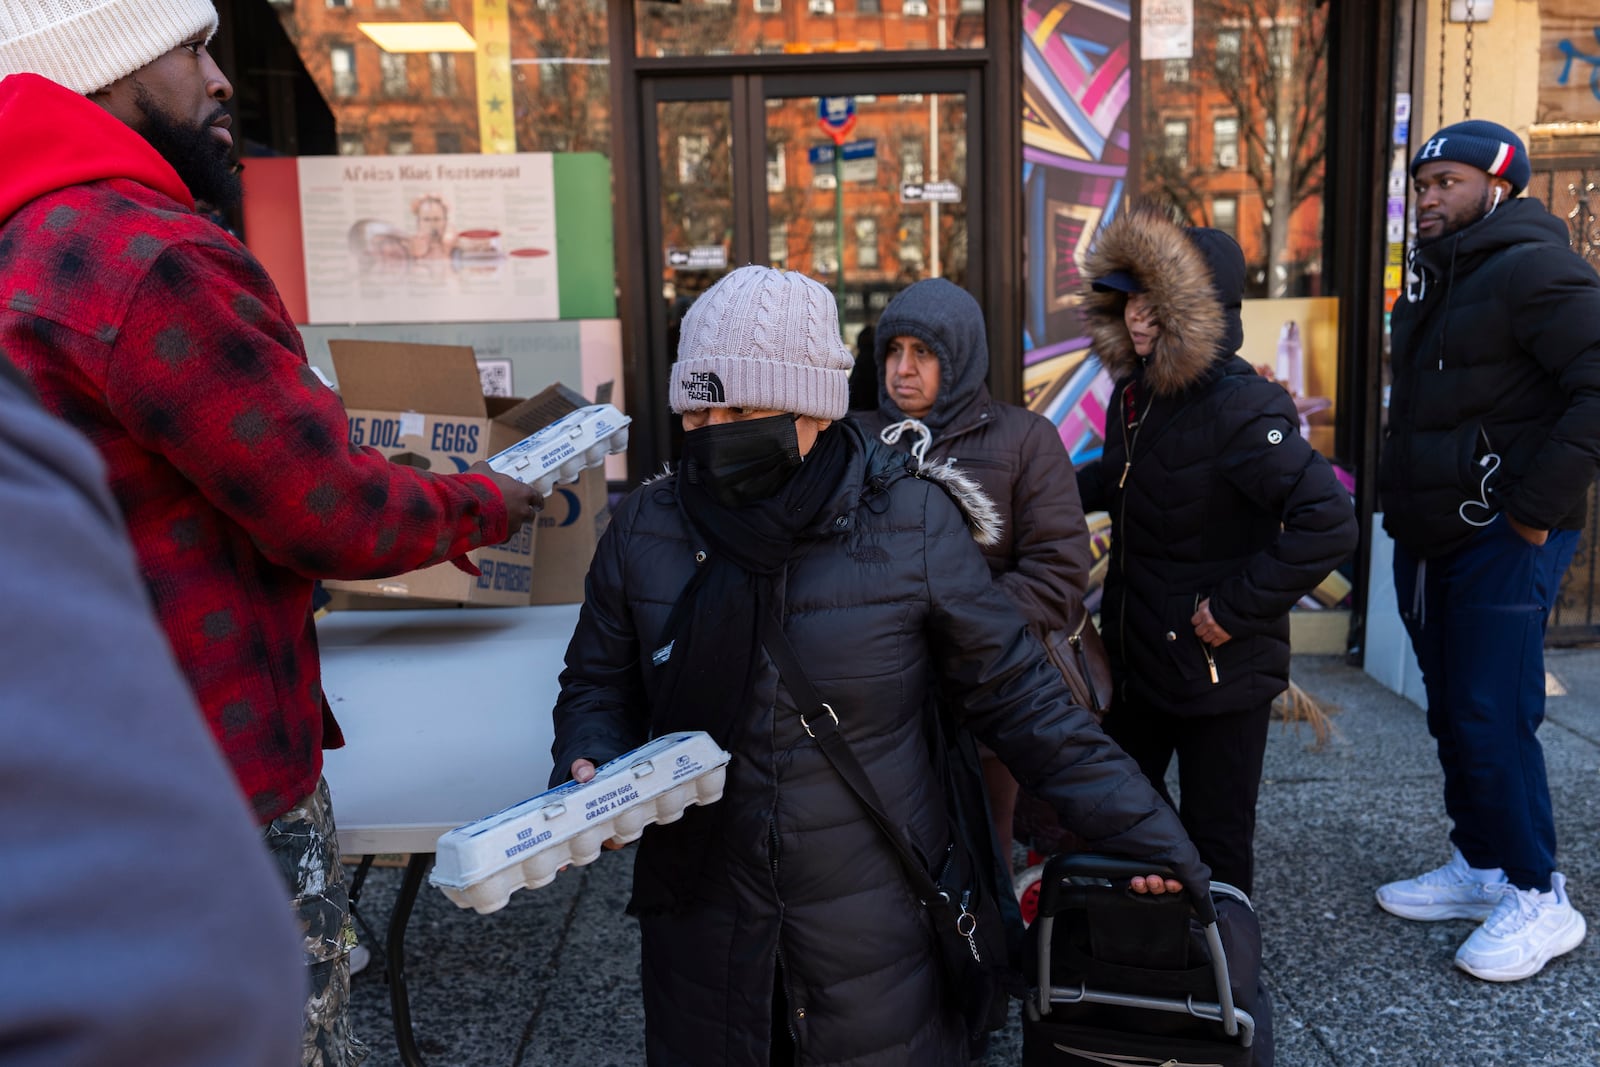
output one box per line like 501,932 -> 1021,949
1378,200 -> 1600,558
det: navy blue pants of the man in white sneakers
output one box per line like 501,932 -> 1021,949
1395,517 -> 1578,889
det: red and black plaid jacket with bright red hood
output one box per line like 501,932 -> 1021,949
0,74 -> 507,822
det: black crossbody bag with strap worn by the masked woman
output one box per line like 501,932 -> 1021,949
762,614 -> 1026,1046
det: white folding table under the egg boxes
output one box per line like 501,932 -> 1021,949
317,605 -> 579,1067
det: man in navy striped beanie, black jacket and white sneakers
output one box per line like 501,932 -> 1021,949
1378,120 -> 1600,982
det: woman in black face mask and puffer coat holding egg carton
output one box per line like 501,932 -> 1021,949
554,267 -> 1210,1067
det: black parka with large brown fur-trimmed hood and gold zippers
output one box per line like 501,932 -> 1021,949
1078,206 -> 1355,715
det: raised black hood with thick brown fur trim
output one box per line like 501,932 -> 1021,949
1082,203 -> 1245,397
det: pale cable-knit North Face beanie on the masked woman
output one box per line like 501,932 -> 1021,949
670,266 -> 856,419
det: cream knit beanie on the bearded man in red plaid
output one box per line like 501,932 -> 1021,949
0,0 -> 216,94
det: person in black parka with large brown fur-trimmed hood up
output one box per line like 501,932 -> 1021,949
1078,203 -> 1355,893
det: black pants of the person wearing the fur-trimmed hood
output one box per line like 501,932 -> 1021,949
1106,701 -> 1272,894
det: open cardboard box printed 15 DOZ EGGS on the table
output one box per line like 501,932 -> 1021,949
323,341 -> 536,606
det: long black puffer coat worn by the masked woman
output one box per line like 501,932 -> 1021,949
554,422 -> 1208,1067
